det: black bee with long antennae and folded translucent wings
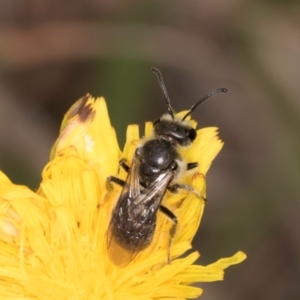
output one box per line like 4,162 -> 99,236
107,68 -> 227,267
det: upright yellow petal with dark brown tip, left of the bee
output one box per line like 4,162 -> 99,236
51,94 -> 121,185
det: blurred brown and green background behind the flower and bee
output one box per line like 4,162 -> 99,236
0,0 -> 300,300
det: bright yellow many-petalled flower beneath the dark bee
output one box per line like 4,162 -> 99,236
0,95 -> 246,300
